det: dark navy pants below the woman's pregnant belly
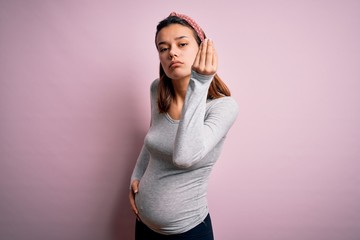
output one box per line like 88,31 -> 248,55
135,214 -> 214,240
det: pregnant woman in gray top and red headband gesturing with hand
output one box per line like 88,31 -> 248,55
129,13 -> 238,240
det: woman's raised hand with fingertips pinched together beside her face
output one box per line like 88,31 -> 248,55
192,39 -> 218,75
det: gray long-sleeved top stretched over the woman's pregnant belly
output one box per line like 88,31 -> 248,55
131,71 -> 238,235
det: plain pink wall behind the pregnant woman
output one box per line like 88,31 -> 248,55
0,0 -> 360,240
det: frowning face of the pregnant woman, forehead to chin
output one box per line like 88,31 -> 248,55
156,24 -> 199,80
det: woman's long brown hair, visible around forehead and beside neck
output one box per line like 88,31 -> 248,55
155,16 -> 231,113
